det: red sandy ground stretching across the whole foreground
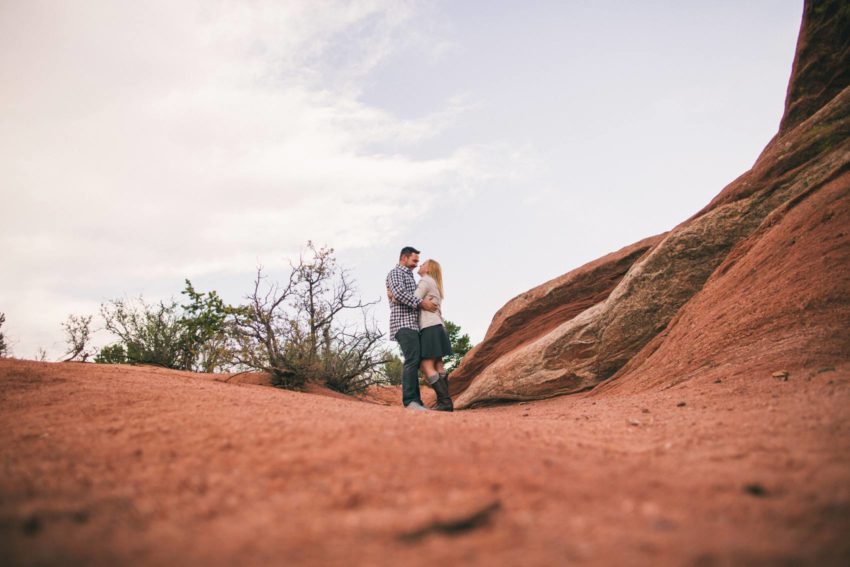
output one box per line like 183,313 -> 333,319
0,360 -> 850,566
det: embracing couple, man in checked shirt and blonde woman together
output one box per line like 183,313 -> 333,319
387,246 -> 453,411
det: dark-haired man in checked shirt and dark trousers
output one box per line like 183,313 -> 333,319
387,246 -> 437,411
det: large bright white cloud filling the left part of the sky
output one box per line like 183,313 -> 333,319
0,0 -> 480,355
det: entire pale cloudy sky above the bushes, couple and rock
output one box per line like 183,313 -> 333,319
0,0 -> 802,358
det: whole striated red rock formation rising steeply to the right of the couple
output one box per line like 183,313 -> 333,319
453,2 -> 850,408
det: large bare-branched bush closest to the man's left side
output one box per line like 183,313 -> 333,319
232,242 -> 387,393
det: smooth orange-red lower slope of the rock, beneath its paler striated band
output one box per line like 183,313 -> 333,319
593,166 -> 850,395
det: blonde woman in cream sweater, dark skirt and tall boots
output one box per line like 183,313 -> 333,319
416,260 -> 454,411
